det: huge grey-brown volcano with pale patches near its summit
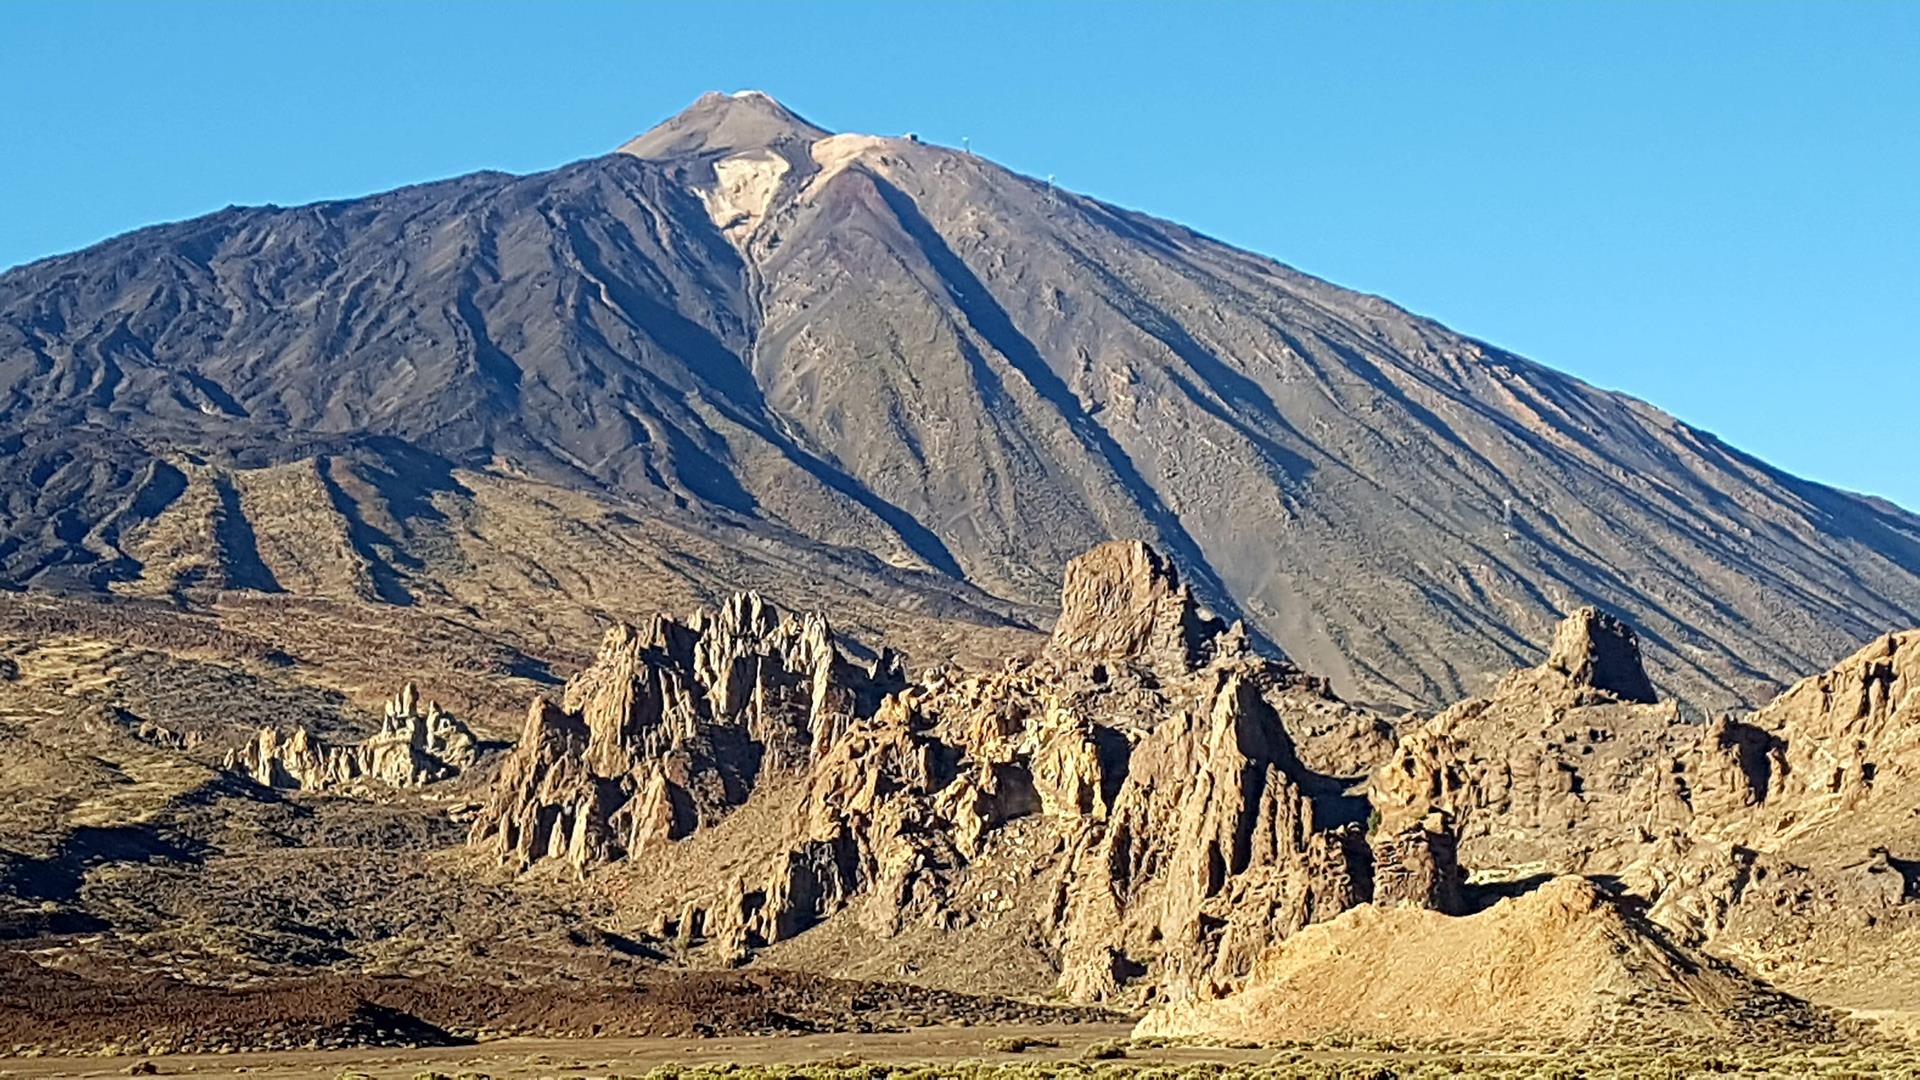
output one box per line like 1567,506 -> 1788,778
0,94 -> 1920,707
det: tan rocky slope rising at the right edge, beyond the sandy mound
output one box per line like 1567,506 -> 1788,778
1624,630 -> 1920,1007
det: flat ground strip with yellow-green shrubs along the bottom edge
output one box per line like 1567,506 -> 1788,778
15,1026 -> 1920,1080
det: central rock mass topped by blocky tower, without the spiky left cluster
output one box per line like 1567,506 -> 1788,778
560,542 -> 1377,1001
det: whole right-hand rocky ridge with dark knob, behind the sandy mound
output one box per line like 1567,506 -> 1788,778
1371,611 -> 1920,1015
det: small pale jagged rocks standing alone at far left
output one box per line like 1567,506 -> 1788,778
225,682 -> 480,792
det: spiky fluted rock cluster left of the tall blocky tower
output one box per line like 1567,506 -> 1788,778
472,594 -> 900,871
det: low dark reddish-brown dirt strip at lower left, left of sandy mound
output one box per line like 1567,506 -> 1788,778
0,953 -> 1116,1053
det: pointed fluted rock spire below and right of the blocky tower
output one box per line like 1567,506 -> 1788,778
1060,663 -> 1371,999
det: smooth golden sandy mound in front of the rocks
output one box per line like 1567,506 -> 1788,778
1137,876 -> 1834,1042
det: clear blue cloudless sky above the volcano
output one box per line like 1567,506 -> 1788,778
0,0 -> 1920,509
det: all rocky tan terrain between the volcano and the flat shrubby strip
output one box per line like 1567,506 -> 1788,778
0,542 -> 1920,1053
